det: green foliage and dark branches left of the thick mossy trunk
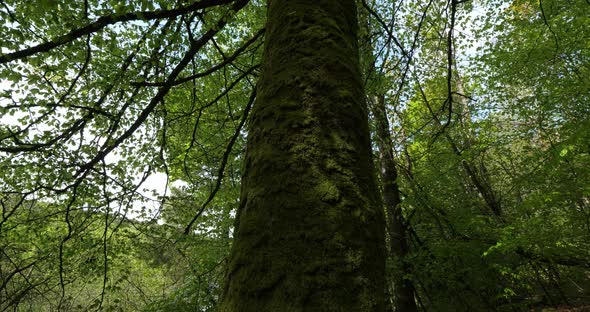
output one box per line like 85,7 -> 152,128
0,0 -> 264,311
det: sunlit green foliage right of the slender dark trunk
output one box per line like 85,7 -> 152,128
369,0 -> 590,311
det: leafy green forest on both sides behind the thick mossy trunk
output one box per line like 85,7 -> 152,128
0,0 -> 590,311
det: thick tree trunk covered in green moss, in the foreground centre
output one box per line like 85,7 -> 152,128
220,0 -> 385,312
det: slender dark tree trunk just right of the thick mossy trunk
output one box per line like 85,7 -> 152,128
373,94 -> 418,312
